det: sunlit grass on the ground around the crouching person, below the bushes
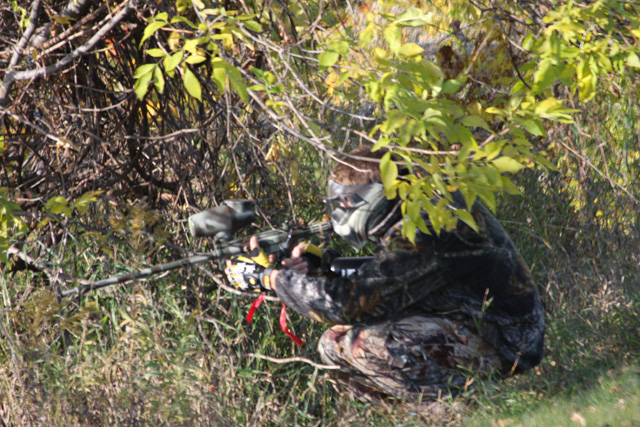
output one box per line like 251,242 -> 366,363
0,92 -> 640,426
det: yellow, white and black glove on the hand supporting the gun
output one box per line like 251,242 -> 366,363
224,248 -> 274,292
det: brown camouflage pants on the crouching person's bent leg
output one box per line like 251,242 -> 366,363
318,315 -> 505,401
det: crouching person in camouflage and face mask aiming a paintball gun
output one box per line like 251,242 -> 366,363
225,147 -> 545,401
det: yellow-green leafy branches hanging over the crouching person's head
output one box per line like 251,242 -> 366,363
127,1 -> 638,238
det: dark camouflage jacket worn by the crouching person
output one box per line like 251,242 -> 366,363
276,204 -> 545,370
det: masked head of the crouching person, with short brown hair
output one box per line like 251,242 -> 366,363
325,146 -> 395,249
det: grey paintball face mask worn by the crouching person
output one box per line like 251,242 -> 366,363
325,181 -> 389,250
